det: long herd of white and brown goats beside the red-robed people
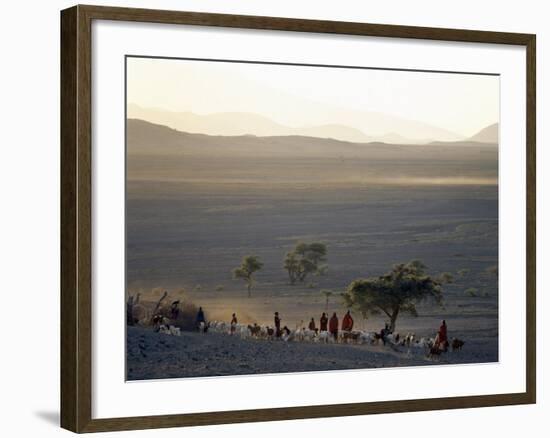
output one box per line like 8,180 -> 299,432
156,318 -> 464,357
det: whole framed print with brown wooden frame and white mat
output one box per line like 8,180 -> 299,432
61,6 -> 536,432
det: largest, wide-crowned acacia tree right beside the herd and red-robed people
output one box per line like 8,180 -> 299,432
342,260 -> 452,331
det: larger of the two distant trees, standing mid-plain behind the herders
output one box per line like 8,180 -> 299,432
283,242 -> 327,284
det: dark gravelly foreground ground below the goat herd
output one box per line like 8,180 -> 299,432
127,327 -> 498,380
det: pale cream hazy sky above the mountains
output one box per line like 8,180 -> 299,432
127,58 -> 499,137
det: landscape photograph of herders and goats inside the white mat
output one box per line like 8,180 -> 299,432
126,56 -> 500,381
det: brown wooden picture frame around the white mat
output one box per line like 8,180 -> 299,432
61,6 -> 536,432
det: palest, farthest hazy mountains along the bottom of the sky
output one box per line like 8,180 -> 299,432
127,104 -> 498,144
